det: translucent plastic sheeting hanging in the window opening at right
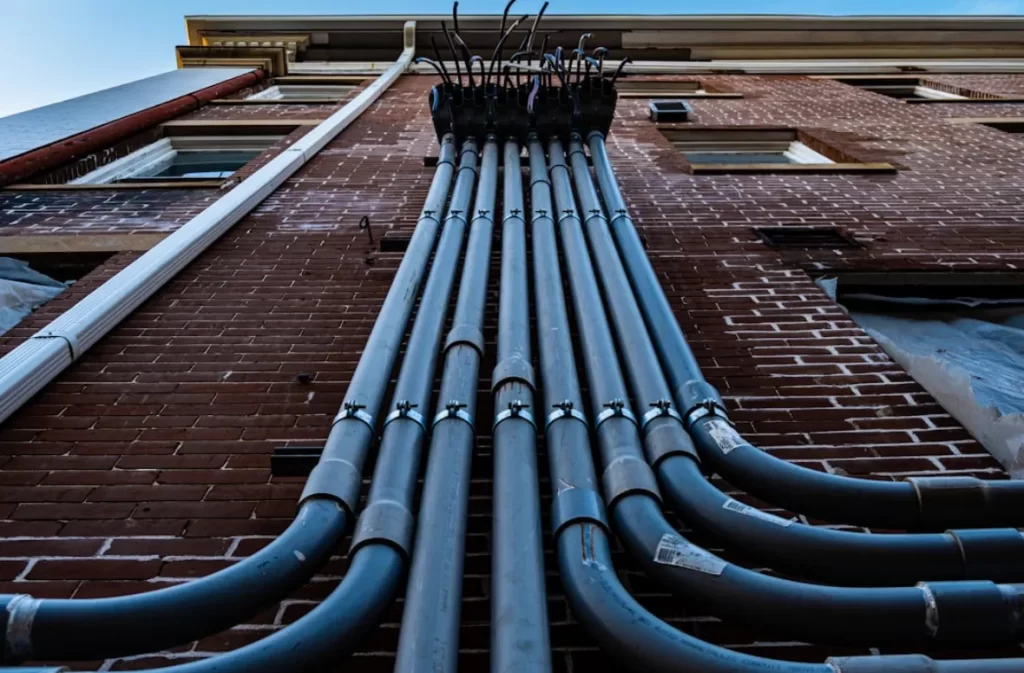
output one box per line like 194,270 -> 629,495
822,281 -> 1024,478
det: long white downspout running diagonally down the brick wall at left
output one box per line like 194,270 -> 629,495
0,22 -> 416,422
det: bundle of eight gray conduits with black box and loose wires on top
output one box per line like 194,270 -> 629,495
6,2 -> 1024,673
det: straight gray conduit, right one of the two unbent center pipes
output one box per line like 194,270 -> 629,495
490,139 -> 551,673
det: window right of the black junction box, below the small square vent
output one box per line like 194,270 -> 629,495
660,127 -> 894,173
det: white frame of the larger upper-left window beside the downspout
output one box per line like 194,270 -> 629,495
68,135 -> 284,184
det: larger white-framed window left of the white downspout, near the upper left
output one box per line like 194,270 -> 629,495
69,135 -> 282,184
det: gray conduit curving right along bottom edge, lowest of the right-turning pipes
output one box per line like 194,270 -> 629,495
529,131 -> 1024,673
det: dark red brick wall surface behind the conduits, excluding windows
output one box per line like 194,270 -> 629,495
0,70 -> 1024,673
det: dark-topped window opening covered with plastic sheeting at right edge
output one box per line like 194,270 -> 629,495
818,271 -> 1024,478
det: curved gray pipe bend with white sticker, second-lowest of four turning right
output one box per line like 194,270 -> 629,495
610,495 -> 1024,646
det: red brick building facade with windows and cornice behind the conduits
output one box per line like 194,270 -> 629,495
0,11 -> 1024,673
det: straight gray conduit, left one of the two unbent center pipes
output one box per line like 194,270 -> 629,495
394,136 -> 498,673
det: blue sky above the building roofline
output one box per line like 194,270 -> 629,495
0,0 -> 1024,117
